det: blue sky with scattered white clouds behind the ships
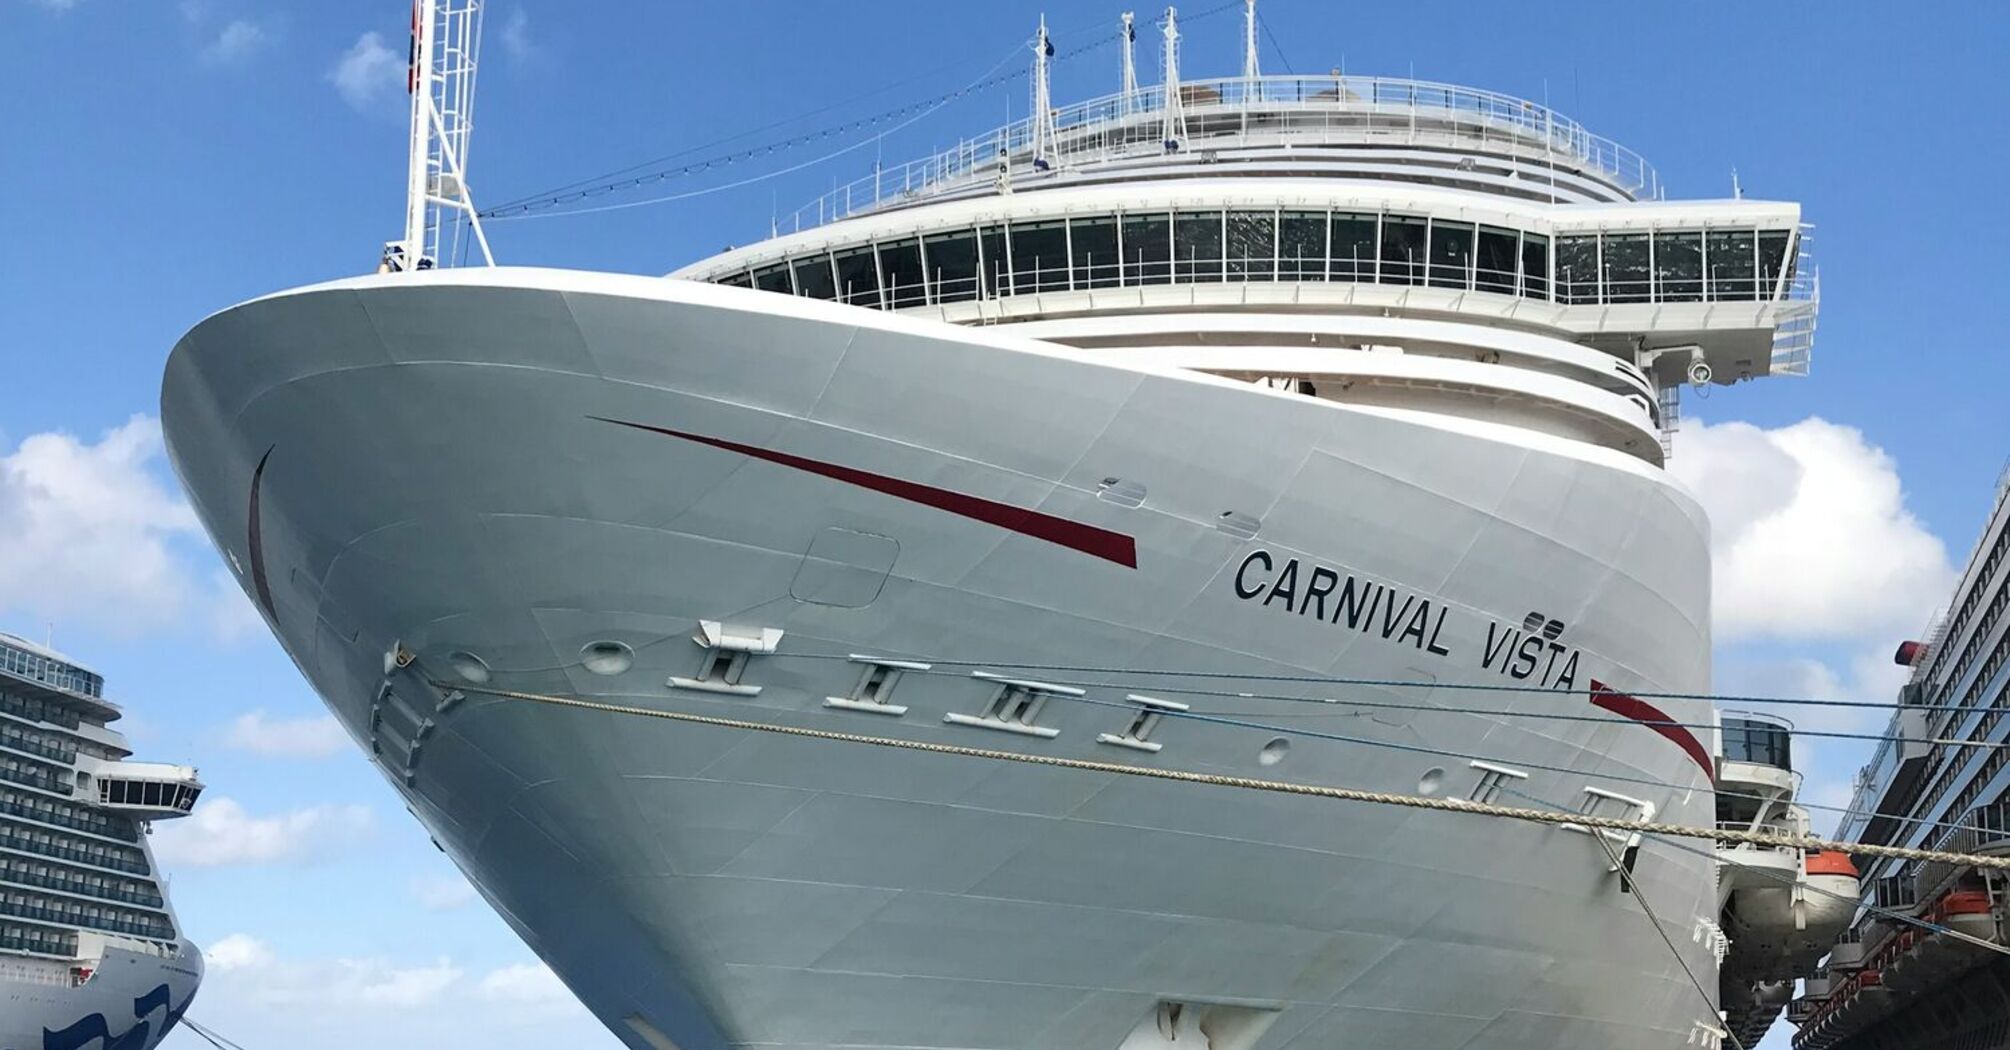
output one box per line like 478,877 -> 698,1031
0,0 -> 2010,1050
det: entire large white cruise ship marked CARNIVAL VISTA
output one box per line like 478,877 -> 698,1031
161,0 -> 1855,1050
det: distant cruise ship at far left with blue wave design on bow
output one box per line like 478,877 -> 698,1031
0,634 -> 203,1050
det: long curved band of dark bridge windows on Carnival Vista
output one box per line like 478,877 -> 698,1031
714,209 -> 1791,310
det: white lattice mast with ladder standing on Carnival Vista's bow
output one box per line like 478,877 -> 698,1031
378,0 -> 494,272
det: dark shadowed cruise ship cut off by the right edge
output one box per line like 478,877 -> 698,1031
1787,473 -> 2010,1050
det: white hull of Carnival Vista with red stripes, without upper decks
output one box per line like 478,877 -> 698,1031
163,270 -> 1717,1050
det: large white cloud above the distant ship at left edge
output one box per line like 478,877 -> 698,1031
0,416 -> 257,638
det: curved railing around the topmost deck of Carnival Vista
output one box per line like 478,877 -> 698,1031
778,76 -> 1660,231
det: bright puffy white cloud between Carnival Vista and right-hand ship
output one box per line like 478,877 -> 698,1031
1668,418 -> 1954,640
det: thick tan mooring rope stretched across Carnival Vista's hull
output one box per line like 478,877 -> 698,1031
432,682 -> 2010,871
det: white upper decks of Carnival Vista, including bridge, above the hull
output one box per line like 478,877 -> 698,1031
673,23 -> 1819,463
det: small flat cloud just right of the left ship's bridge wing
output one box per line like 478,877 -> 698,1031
153,797 -> 372,867
